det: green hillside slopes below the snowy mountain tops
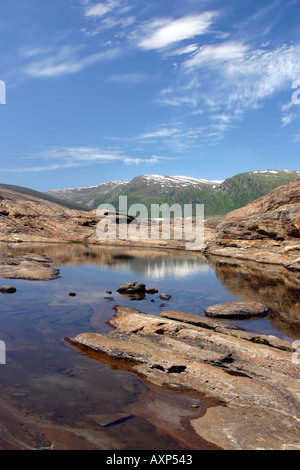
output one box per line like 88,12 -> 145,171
93,170 -> 300,216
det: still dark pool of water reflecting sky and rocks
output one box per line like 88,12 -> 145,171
0,244 -> 300,450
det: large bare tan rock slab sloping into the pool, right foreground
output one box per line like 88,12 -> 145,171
68,306 -> 300,449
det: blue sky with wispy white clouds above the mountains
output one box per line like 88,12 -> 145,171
0,0 -> 300,191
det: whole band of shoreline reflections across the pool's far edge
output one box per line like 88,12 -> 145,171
5,243 -> 300,340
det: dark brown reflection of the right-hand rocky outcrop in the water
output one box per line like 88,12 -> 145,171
207,257 -> 300,340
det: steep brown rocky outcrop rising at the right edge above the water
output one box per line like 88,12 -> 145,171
205,179 -> 300,271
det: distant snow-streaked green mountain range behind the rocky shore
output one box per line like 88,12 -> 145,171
46,170 -> 300,216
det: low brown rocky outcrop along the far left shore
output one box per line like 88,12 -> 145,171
0,187 -> 215,249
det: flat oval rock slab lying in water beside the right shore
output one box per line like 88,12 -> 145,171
204,302 -> 269,320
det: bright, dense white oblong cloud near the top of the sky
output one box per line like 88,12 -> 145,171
138,11 -> 217,50
